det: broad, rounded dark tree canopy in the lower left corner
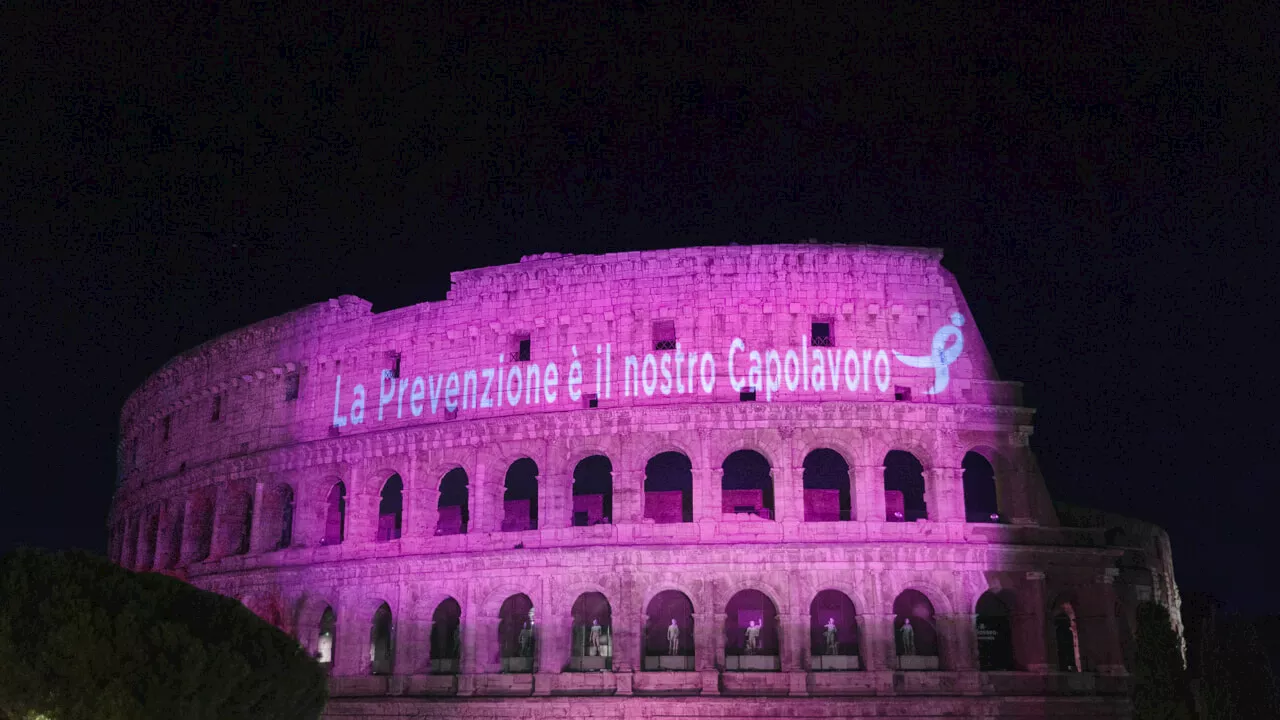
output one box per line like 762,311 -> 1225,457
0,550 -> 326,720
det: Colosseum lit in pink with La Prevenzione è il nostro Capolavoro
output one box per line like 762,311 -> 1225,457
109,245 -> 1179,720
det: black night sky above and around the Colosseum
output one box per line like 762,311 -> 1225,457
0,1 -> 1280,612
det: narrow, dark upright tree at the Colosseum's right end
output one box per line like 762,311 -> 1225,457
1133,602 -> 1194,720
